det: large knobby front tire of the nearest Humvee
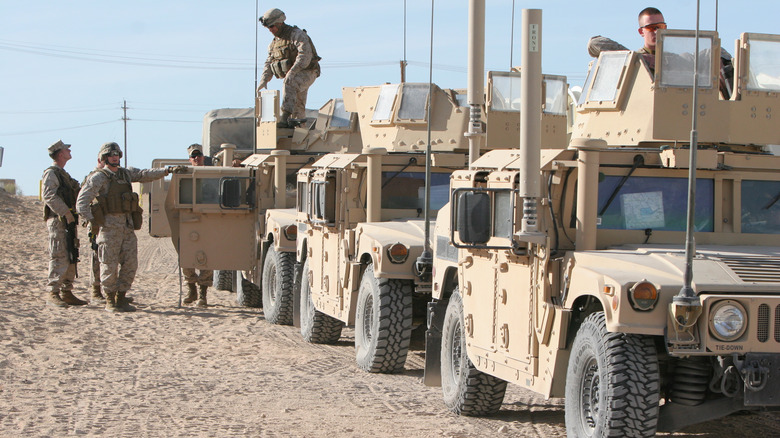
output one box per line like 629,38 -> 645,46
565,312 -> 660,437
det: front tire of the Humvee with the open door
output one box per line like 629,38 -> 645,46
262,245 -> 295,325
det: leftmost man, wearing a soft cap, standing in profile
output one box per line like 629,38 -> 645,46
43,140 -> 87,307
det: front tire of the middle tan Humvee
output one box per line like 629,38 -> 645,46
355,265 -> 412,373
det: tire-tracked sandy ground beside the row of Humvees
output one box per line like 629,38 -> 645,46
0,191 -> 780,437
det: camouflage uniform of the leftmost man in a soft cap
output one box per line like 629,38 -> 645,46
43,159 -> 86,306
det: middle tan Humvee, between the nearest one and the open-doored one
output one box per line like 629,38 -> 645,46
295,72 -> 568,373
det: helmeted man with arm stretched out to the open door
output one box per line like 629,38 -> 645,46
76,142 -> 186,312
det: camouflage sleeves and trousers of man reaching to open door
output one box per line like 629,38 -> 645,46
76,167 -> 167,310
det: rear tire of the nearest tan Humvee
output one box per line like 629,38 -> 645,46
441,289 -> 506,417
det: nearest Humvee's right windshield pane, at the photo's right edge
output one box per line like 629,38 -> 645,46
741,180 -> 780,234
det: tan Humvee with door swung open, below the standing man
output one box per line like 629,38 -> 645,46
152,90 -> 361,308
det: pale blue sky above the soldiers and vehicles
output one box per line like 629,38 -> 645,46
0,0 -> 780,196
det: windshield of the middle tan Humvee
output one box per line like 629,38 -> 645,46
382,171 -> 450,210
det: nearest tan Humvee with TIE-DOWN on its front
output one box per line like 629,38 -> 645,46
424,5 -> 780,437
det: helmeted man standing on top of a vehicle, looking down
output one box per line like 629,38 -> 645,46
257,8 -> 322,128
